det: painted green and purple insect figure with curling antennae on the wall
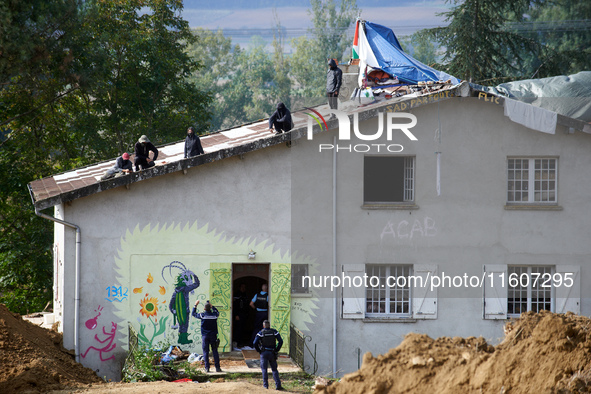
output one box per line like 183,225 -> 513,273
162,261 -> 199,344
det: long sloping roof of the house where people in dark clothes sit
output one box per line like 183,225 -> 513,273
29,85 -> 480,209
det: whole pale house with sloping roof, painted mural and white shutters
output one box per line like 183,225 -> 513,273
29,74 -> 591,379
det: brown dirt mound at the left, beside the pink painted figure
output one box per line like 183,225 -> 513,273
0,304 -> 102,393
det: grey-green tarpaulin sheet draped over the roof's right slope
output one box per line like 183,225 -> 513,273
472,71 -> 591,122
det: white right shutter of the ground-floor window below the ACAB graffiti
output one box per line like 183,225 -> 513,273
411,264 -> 437,319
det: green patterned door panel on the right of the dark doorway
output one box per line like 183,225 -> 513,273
270,263 -> 291,353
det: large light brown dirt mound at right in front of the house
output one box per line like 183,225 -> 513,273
314,312 -> 591,394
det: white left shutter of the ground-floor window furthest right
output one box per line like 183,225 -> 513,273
482,264 -> 509,320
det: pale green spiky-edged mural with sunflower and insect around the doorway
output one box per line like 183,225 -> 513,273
114,221 -> 318,351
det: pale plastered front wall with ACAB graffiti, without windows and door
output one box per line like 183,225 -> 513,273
56,94 -> 591,379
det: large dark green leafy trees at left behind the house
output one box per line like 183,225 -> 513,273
0,0 -> 209,313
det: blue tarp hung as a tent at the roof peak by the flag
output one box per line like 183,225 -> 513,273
365,22 -> 460,84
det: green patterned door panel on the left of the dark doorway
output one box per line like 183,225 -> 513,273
207,263 -> 232,352
